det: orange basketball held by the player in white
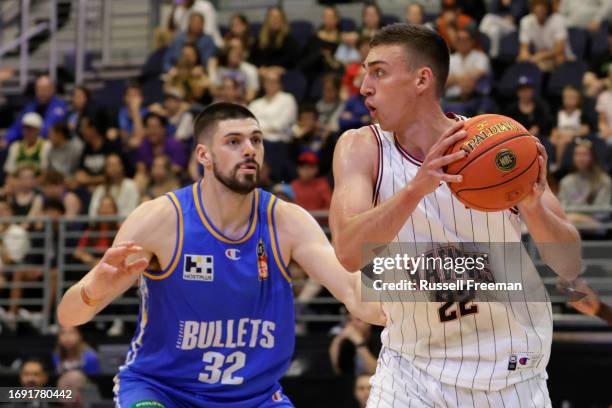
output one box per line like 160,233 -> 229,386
446,114 -> 539,211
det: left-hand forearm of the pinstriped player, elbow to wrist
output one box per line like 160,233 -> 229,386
332,184 -> 423,271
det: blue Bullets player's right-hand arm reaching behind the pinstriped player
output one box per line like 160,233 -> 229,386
275,201 -> 386,326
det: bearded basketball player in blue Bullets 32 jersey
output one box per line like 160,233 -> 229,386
58,103 -> 384,408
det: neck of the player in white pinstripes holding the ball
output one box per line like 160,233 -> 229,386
395,104 -> 455,160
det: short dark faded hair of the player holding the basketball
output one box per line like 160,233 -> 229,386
370,23 -> 450,96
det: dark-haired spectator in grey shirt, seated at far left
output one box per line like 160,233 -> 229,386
47,123 -> 84,178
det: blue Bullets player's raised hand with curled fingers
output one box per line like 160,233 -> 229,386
84,242 -> 149,300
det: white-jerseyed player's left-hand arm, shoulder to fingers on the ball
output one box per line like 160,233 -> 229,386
329,122 -> 465,271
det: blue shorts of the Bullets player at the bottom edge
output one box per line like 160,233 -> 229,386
113,375 -> 293,408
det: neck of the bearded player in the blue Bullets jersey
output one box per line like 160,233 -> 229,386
200,177 -> 255,239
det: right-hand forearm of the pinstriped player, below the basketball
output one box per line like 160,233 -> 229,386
519,205 -> 582,280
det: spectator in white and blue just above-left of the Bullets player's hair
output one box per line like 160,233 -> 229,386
149,88 -> 193,143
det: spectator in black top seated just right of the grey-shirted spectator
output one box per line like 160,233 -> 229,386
76,114 -> 121,187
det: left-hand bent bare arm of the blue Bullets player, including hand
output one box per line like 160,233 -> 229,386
57,197 -> 177,326
